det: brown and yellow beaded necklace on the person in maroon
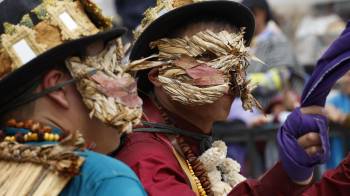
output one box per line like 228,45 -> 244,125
153,98 -> 214,196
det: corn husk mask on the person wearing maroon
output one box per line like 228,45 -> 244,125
129,28 -> 261,110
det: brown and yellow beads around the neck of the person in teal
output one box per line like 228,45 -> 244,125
0,119 -> 64,143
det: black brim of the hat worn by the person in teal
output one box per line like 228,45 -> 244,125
0,28 -> 126,105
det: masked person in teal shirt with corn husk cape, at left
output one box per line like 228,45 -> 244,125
0,0 -> 145,195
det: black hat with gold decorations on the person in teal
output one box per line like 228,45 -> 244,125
0,0 -> 125,107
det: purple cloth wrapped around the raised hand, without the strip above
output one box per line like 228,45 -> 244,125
277,108 -> 329,181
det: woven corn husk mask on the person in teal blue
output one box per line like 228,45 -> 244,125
66,41 -> 142,133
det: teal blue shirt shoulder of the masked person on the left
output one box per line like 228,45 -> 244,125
60,150 -> 147,196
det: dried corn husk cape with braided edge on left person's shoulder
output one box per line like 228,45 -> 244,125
0,133 -> 84,195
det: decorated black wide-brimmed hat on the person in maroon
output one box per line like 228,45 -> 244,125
129,0 -> 255,92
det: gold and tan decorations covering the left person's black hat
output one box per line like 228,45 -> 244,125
0,0 -> 112,78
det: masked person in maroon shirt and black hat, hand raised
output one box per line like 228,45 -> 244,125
117,0 -> 327,195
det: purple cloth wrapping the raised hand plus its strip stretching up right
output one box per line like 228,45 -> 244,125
277,23 -> 350,181
